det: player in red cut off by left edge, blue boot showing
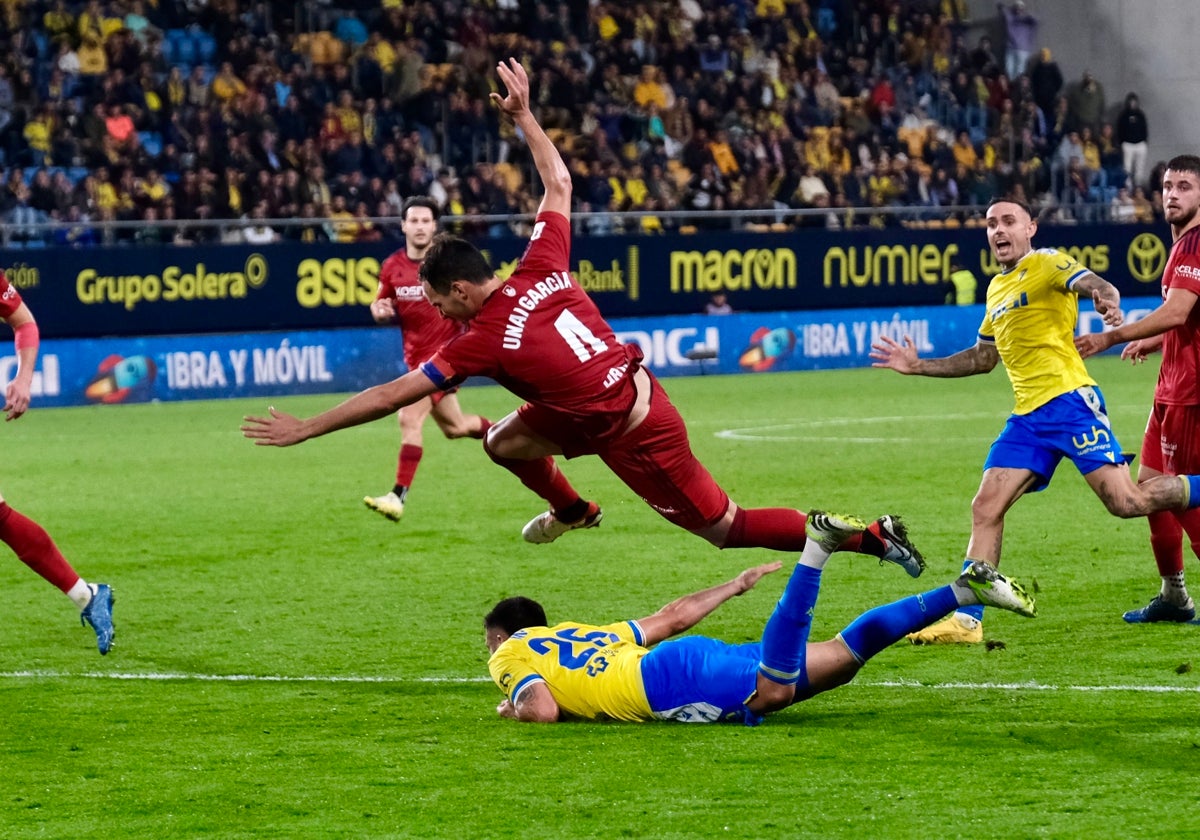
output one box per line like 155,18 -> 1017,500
0,271 -> 114,654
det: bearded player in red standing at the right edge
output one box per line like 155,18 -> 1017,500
1075,155 -> 1200,624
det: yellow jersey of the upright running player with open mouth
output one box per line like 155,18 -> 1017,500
979,248 -> 1096,414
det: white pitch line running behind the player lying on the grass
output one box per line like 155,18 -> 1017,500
0,671 -> 1200,694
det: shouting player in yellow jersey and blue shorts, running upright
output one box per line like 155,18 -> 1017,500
871,198 -> 1200,644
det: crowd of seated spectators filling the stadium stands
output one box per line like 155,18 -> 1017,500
0,0 -> 1162,246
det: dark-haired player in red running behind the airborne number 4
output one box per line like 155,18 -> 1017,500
362,196 -> 491,522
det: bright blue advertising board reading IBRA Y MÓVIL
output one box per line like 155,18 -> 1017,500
0,298 -> 1159,407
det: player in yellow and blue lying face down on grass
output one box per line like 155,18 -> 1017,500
484,511 -> 1036,726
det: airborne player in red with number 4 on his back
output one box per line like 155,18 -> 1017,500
241,59 -> 924,577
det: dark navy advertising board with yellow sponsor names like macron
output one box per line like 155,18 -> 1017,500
0,224 -> 1168,337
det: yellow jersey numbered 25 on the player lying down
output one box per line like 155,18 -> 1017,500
487,622 -> 654,720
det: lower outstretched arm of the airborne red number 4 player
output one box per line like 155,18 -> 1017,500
241,370 -> 437,446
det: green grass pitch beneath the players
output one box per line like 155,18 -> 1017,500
0,359 -> 1200,839
